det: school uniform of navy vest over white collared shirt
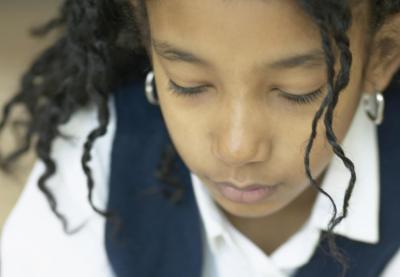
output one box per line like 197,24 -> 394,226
0,75 -> 400,277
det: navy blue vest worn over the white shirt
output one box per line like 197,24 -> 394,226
105,76 -> 400,277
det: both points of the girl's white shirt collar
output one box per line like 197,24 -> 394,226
191,94 -> 379,254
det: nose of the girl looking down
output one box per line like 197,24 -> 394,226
212,101 -> 271,167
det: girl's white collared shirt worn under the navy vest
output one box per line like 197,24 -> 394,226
0,95 -> 400,277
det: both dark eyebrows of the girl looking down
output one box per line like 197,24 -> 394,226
152,39 -> 325,69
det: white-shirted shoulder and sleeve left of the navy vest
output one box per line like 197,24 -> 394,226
0,96 -> 116,277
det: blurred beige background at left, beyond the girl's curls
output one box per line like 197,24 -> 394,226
0,0 -> 61,232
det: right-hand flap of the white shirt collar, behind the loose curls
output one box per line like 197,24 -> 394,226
310,94 -> 380,243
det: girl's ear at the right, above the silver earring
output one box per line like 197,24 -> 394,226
363,13 -> 400,93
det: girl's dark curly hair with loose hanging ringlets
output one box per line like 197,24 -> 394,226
0,0 -> 400,274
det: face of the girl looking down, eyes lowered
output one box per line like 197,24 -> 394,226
147,0 -> 367,218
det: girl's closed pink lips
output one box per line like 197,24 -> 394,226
214,182 -> 277,204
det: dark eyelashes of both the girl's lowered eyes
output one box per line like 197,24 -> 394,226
168,80 -> 323,105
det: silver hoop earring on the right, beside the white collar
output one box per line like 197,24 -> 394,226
363,92 -> 385,125
